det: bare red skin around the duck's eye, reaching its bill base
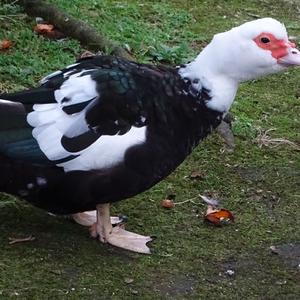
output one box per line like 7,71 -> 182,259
254,32 -> 296,60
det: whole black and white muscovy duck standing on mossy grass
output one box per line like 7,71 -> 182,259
0,18 -> 300,253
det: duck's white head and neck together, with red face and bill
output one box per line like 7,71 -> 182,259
179,18 -> 300,110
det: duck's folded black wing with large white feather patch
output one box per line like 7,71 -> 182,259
0,57 -> 176,170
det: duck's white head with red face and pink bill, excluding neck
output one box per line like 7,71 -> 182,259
209,18 -> 300,82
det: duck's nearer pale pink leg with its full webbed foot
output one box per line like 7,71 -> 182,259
91,203 -> 152,254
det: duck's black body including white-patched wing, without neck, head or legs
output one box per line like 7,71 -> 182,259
0,56 -> 222,214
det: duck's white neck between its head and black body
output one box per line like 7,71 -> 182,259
179,45 -> 239,113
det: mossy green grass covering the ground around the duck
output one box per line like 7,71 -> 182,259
0,0 -> 300,299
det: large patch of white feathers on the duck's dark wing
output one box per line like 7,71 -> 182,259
27,70 -> 146,171
